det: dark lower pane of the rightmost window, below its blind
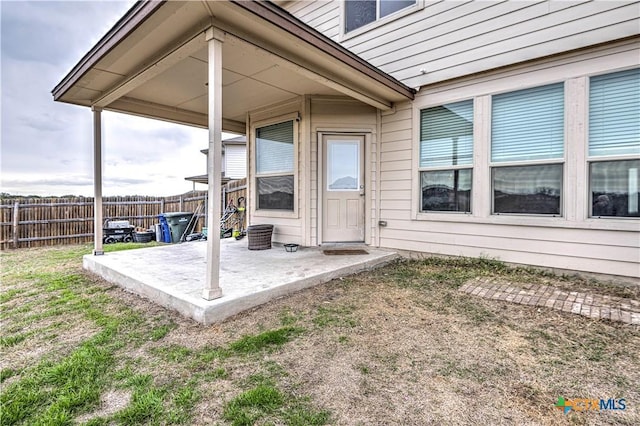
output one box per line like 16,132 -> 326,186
589,160 -> 640,217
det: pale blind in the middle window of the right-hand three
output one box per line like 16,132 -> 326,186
491,83 -> 564,162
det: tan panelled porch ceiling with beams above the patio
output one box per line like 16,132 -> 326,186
53,1 -> 413,133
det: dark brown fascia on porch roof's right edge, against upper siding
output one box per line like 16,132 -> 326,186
230,0 -> 416,99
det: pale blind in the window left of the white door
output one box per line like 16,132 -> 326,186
256,121 -> 294,174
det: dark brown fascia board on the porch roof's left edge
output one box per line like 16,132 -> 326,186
51,0 -> 166,101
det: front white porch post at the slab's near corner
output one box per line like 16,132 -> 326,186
202,27 -> 224,300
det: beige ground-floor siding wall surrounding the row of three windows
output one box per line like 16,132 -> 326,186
379,37 -> 640,278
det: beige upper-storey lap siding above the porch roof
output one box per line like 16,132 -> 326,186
284,0 -> 640,88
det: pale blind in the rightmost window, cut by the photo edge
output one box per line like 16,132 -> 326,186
589,69 -> 640,156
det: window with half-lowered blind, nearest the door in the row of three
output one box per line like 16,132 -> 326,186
419,100 -> 473,213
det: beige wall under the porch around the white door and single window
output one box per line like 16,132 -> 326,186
247,96 -> 379,246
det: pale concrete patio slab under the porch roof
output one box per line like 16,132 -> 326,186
83,238 -> 397,324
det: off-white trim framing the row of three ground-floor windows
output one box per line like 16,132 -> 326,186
410,63 -> 640,232
